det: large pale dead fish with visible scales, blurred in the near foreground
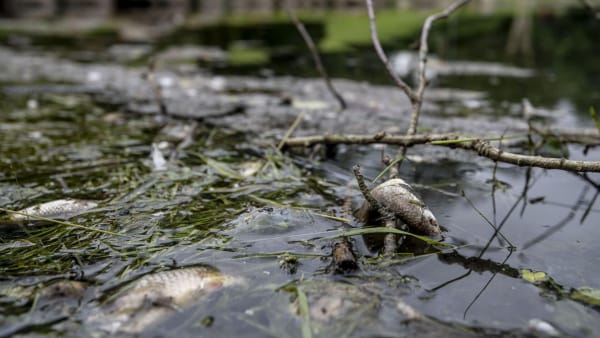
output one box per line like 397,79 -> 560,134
101,266 -> 242,333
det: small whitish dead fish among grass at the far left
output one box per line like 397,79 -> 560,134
9,198 -> 98,221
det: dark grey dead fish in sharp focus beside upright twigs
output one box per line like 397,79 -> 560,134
358,178 -> 441,235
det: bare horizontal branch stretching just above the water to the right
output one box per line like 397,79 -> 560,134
284,134 -> 600,172
